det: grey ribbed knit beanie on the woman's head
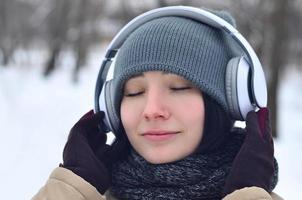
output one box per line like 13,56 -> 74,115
112,11 -> 235,116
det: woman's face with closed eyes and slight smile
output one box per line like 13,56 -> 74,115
121,71 -> 204,164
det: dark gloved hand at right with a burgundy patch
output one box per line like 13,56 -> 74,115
223,108 -> 274,196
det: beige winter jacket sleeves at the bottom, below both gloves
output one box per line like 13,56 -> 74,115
32,167 -> 282,200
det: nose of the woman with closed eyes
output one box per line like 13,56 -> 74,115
143,90 -> 171,120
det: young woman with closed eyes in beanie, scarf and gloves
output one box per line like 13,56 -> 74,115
33,6 -> 281,200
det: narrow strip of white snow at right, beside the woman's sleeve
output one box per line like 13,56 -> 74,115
275,67 -> 302,200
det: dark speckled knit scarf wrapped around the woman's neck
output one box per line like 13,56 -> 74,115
110,131 -> 243,200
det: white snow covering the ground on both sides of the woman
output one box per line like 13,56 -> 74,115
0,49 -> 302,200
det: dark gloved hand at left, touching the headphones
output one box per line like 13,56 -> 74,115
61,111 -> 125,194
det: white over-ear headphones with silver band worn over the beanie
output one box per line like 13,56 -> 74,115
94,6 -> 267,133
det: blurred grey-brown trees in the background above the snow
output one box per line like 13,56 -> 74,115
0,0 -> 302,136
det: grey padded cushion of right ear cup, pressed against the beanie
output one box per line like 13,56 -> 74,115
225,57 -> 242,119
